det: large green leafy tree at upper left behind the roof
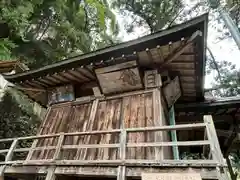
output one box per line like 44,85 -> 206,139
0,0 -> 118,68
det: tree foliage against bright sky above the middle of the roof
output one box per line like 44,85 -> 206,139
112,0 -> 182,32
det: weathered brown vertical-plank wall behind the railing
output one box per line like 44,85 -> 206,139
32,90 -> 171,160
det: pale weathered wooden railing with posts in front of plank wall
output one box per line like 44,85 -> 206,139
0,120 -> 225,167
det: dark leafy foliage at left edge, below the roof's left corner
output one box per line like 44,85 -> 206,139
0,89 -> 40,138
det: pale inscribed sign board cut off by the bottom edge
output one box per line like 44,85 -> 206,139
142,173 -> 202,180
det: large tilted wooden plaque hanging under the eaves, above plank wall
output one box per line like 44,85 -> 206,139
95,61 -> 143,94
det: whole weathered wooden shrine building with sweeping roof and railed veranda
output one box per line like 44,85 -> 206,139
0,14 -> 240,180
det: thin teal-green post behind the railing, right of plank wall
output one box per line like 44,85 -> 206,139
169,105 -> 179,160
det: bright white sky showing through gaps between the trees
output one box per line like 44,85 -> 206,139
114,0 -> 240,88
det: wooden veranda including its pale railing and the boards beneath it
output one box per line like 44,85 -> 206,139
0,113 -> 226,180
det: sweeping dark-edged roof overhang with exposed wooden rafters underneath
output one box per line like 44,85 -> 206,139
4,14 -> 208,107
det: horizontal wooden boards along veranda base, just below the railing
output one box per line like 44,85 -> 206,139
4,166 -> 218,179
